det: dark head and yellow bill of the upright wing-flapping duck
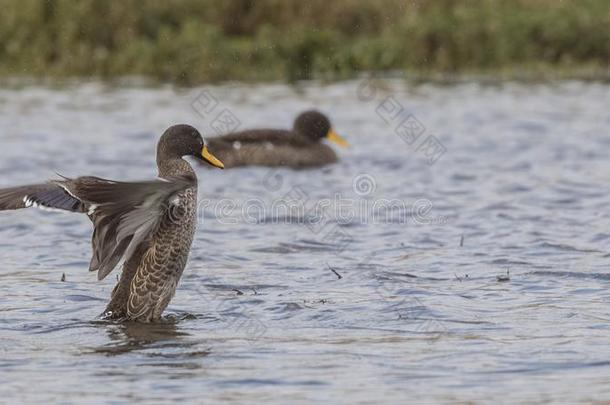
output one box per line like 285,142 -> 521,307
157,124 -> 224,169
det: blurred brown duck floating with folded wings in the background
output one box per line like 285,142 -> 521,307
208,110 -> 349,169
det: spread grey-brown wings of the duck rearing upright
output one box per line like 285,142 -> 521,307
0,177 -> 196,280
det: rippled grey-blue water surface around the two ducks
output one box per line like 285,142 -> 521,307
0,81 -> 610,404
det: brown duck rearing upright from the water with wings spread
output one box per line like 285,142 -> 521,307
0,124 -> 224,323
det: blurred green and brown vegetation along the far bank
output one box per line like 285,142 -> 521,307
0,0 -> 610,84
